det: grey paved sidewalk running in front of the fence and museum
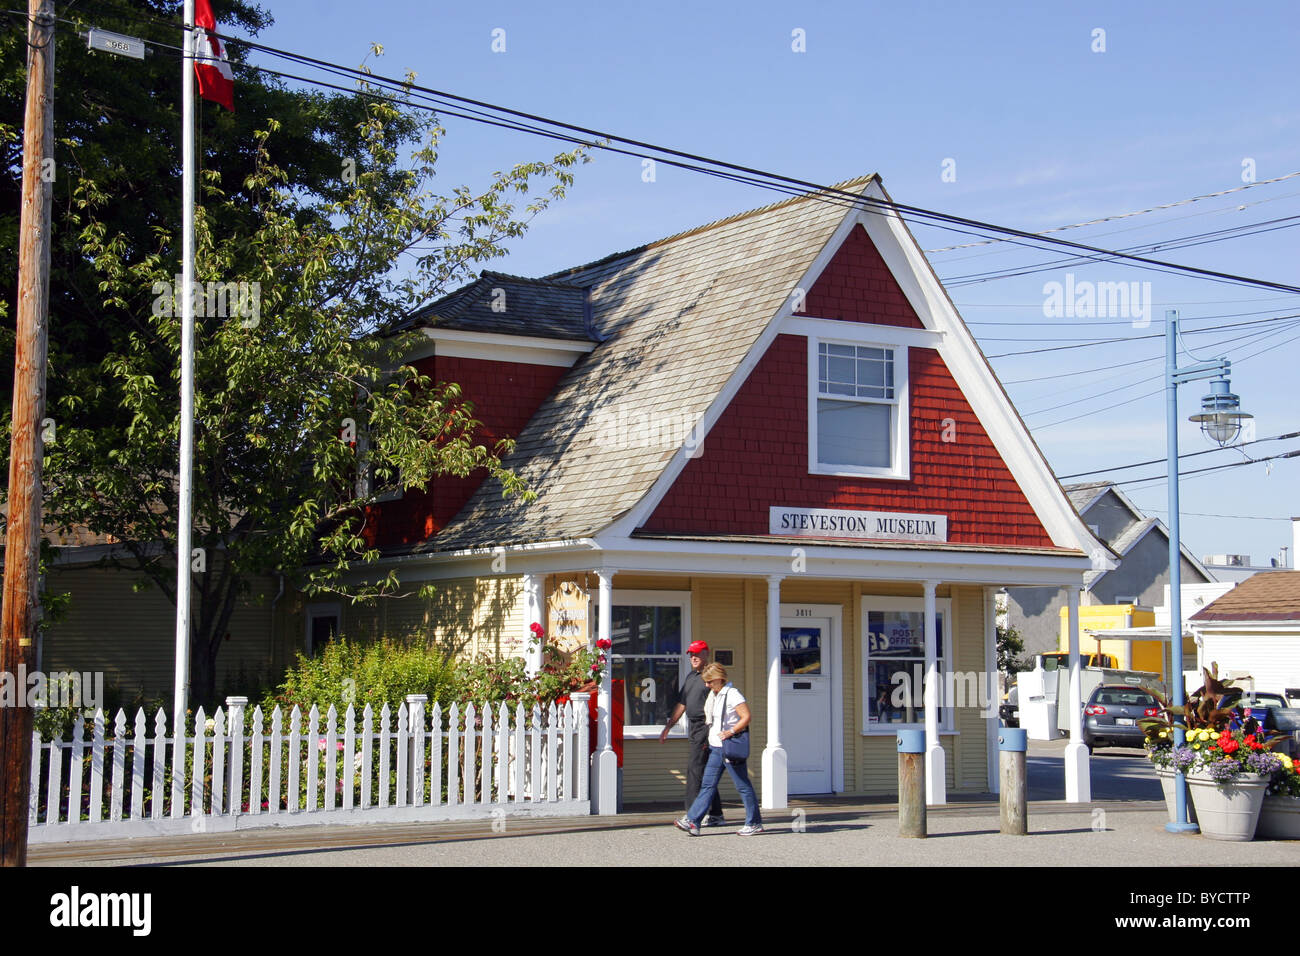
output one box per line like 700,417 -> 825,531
29,797 -> 1300,868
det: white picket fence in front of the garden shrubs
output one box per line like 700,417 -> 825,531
27,693 -> 590,843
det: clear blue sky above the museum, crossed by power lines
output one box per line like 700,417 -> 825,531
245,0 -> 1300,563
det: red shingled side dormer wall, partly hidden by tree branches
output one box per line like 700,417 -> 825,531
363,356 -> 568,546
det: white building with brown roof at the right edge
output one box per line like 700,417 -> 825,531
1188,571 -> 1300,700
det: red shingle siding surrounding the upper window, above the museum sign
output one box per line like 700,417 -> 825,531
644,335 -> 1052,548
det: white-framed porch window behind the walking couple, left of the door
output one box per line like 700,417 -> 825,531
590,591 -> 692,737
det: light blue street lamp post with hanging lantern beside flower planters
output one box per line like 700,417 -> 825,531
1165,310 -> 1252,834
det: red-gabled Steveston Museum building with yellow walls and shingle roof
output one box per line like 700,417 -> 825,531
325,176 -> 1106,812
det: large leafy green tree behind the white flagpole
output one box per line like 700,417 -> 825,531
0,3 -> 585,700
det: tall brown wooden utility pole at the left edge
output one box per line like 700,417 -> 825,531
0,0 -> 55,866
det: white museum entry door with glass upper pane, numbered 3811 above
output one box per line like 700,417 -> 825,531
781,617 -> 835,793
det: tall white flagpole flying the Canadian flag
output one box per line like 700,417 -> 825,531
172,0 -> 194,734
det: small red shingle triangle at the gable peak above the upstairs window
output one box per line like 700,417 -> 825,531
803,226 -> 924,329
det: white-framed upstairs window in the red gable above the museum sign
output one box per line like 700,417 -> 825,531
809,336 -> 910,479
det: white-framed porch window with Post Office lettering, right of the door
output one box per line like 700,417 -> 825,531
862,594 -> 953,734
